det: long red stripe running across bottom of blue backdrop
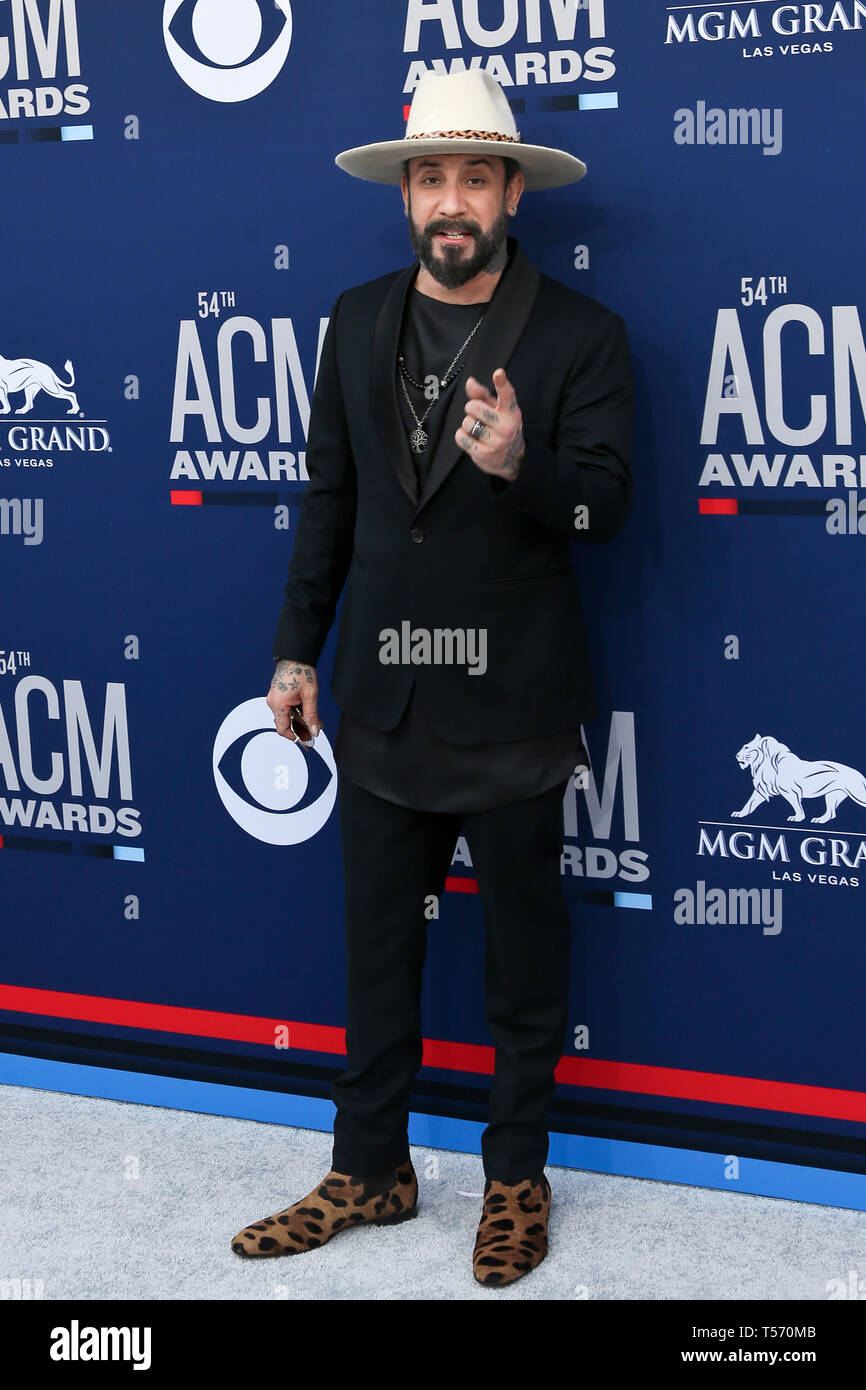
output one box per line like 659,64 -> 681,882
0,984 -> 866,1123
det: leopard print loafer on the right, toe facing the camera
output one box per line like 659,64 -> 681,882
473,1173 -> 550,1284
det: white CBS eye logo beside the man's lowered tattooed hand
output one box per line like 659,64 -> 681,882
213,695 -> 336,845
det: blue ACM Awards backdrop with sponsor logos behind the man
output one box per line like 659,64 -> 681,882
0,0 -> 866,1208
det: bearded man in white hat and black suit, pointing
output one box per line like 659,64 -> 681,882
232,71 -> 632,1284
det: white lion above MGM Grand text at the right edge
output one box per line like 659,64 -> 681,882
731,734 -> 866,824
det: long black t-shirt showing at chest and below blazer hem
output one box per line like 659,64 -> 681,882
334,286 -> 589,812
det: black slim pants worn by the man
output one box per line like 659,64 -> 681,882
331,776 -> 570,1183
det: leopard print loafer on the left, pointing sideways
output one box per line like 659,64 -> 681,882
232,1159 -> 418,1255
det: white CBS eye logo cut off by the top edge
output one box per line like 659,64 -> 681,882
163,0 -> 292,101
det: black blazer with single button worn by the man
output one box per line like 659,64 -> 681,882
272,238 -> 632,744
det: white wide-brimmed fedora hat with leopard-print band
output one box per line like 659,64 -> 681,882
335,68 -> 587,189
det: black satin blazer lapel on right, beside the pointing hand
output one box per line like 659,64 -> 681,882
414,236 -> 541,512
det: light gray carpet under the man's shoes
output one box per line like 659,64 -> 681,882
0,1086 -> 866,1301
